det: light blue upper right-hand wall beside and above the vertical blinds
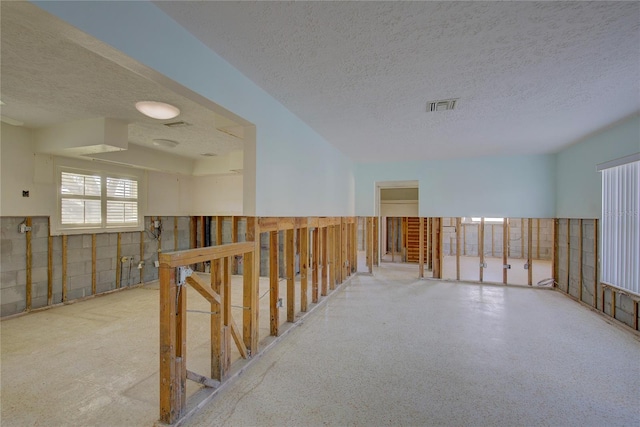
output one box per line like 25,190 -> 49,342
556,115 -> 640,218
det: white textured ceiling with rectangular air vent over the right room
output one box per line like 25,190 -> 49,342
156,1 -> 640,161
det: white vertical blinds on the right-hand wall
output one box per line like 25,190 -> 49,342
602,161 -> 640,294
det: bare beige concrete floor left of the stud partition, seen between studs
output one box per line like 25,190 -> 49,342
0,273 -> 314,427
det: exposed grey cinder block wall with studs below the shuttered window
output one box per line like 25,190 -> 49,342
0,217 -> 190,317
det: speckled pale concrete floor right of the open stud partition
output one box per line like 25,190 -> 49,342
186,265 -> 640,427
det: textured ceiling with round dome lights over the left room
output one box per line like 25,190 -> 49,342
0,1 -> 242,158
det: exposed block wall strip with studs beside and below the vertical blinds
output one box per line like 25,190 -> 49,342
554,218 -> 640,328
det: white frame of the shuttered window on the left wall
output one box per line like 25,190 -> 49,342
51,166 -> 145,235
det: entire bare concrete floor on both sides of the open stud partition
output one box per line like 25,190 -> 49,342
0,264 -> 640,427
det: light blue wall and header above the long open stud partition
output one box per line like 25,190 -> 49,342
33,1 -> 355,216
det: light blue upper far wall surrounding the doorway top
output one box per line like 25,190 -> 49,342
356,155 -> 556,218
